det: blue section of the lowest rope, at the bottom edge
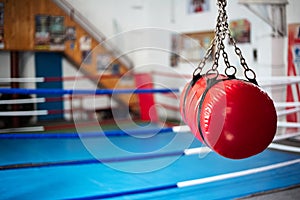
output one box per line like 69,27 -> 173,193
68,184 -> 178,200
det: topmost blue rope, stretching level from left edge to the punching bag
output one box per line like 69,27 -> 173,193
0,88 -> 179,95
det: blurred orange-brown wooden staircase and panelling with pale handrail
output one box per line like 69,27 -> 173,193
0,0 -> 139,113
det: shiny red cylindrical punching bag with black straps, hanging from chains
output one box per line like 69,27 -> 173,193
180,75 -> 277,159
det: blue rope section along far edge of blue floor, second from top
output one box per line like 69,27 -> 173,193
0,127 -> 173,139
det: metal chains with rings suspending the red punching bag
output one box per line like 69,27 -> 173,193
194,0 -> 256,79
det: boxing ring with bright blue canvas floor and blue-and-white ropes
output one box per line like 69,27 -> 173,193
0,74 -> 300,199
